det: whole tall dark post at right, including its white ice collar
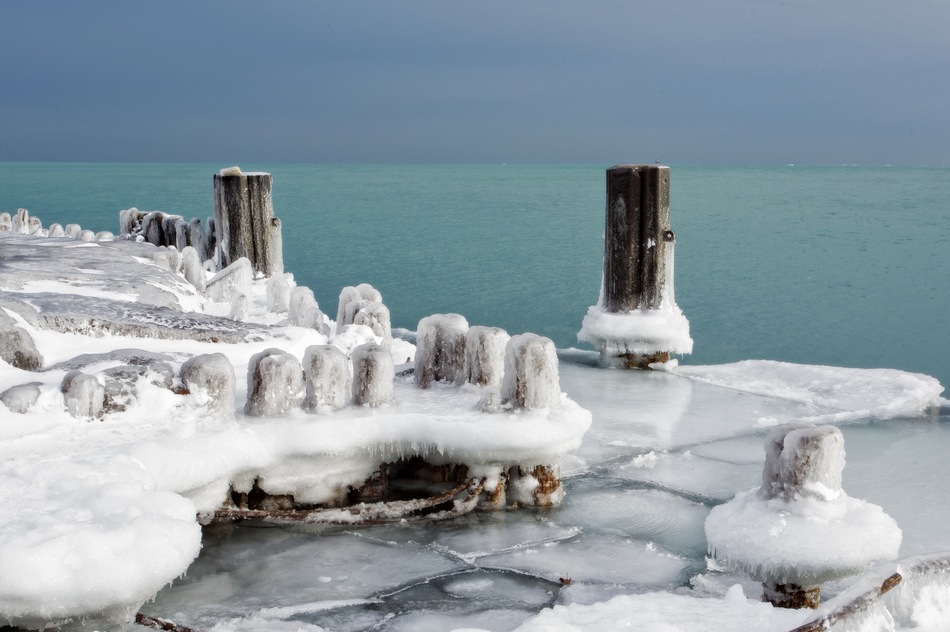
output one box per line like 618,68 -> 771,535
577,165 -> 693,368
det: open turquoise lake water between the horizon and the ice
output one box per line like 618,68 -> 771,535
0,163 -> 950,385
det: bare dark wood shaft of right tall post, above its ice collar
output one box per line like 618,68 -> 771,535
603,165 -> 675,312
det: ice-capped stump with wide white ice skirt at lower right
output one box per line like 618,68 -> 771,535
706,423 -> 901,608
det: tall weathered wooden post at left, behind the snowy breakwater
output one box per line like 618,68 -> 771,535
214,167 -> 284,276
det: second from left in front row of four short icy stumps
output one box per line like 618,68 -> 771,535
244,349 -> 303,417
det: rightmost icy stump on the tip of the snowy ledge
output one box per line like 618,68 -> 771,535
501,333 -> 561,409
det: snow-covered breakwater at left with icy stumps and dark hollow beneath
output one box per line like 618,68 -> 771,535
0,220 -> 590,627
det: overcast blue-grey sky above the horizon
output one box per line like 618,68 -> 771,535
0,0 -> 950,165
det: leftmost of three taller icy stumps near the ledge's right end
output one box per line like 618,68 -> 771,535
414,314 -> 468,388
